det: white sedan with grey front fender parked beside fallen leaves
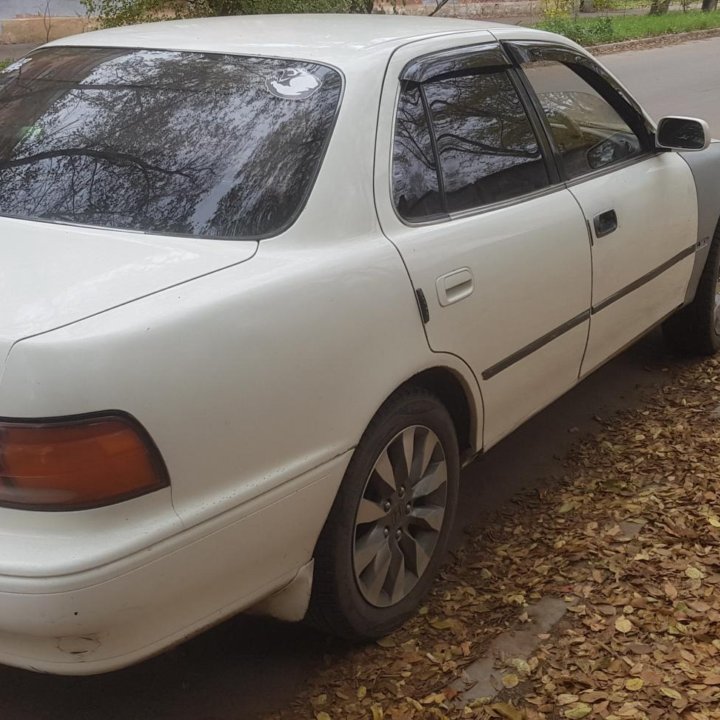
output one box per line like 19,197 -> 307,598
0,16 -> 720,674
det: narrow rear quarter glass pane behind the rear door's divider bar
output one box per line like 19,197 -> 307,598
393,83 -> 442,220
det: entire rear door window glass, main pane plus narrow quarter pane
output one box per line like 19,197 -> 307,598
393,71 -> 549,221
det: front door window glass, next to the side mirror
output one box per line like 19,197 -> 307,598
523,61 -> 642,178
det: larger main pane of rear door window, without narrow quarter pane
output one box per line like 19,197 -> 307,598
424,72 -> 548,212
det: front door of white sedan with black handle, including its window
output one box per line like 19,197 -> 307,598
510,43 -> 697,374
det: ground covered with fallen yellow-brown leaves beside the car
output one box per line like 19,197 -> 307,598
274,360 -> 720,720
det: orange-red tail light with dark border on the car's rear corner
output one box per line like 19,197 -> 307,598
0,415 -> 169,510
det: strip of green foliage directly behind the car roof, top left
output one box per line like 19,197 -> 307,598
81,0 -> 373,27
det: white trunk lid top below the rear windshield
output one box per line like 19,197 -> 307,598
0,218 -> 258,375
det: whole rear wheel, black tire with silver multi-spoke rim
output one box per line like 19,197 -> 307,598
307,388 -> 460,641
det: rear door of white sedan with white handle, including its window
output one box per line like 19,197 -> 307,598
376,39 -> 591,446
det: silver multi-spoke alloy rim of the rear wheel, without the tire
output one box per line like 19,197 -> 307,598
353,425 -> 448,607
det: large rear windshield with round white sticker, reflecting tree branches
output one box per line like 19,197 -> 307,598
0,47 -> 342,239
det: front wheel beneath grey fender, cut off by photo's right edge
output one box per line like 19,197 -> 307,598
663,219 -> 720,355
